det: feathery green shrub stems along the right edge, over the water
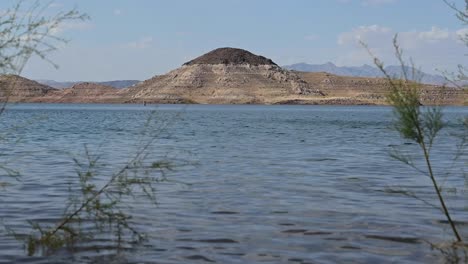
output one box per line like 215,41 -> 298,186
362,0 -> 468,244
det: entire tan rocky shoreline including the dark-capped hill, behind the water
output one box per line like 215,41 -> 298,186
0,48 -> 468,105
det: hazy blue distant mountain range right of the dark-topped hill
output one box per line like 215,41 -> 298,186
283,62 -> 462,85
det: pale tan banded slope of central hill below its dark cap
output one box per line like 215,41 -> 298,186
123,64 -> 321,103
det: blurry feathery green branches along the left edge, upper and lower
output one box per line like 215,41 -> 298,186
0,1 -> 176,255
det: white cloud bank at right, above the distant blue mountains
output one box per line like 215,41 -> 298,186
336,25 -> 468,71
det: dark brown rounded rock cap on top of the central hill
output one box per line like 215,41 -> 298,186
183,48 -> 278,66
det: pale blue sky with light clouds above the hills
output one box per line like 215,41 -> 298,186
0,0 -> 468,81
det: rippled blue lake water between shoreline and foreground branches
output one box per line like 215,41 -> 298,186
0,104 -> 468,263
